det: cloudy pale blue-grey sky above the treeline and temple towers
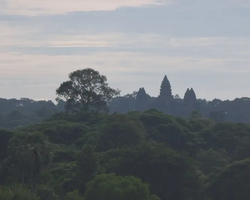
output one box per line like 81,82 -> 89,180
0,0 -> 250,100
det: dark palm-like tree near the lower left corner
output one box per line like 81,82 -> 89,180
6,132 -> 50,191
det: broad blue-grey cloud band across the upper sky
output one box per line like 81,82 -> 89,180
0,0 -> 250,37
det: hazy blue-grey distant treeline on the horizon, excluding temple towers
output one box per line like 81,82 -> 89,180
0,95 -> 250,129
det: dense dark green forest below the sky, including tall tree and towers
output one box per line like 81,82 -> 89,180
0,69 -> 250,200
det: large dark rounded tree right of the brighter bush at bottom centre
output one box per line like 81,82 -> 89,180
101,142 -> 200,200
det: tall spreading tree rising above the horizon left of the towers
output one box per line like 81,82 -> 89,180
56,68 -> 120,110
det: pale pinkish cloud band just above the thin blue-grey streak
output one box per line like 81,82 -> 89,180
0,22 -> 250,50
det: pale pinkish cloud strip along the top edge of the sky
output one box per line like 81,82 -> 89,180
0,0 -> 250,16
